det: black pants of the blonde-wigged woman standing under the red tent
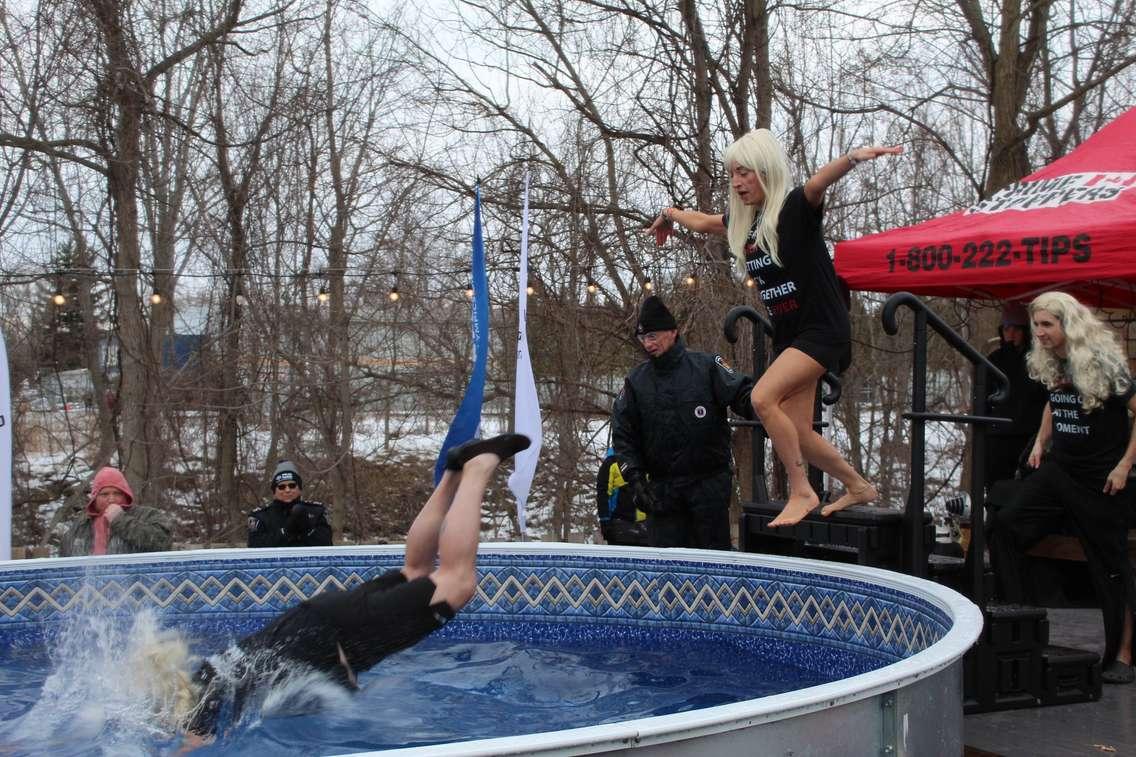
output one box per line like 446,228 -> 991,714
989,461 -> 1136,665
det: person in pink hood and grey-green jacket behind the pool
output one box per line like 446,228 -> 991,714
59,467 -> 173,557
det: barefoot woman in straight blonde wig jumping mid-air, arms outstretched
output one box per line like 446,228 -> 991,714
648,128 -> 903,526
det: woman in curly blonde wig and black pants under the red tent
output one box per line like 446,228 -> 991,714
991,292 -> 1136,683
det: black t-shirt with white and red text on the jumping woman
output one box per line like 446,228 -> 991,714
727,186 -> 851,350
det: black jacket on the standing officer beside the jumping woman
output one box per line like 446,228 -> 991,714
611,339 -> 753,479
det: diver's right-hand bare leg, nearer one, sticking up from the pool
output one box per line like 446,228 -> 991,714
431,452 -> 501,612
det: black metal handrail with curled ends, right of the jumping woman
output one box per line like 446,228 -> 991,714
882,292 -> 1010,607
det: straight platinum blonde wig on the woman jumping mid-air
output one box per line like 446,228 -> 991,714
724,128 -> 790,272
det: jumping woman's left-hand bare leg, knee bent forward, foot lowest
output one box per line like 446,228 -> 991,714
750,347 -> 825,527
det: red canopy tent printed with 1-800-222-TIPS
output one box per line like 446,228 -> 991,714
835,108 -> 1136,308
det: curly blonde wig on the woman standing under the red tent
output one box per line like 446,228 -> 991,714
1026,292 -> 1131,410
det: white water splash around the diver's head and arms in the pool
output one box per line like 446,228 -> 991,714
2,610 -> 352,756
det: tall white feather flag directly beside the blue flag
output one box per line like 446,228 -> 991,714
509,173 -> 541,536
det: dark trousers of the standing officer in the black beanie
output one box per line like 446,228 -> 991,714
646,469 -> 734,550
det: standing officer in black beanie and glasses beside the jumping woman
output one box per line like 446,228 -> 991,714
611,297 -> 753,549
